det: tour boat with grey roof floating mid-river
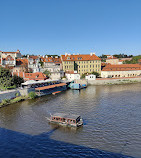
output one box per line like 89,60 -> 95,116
49,113 -> 83,127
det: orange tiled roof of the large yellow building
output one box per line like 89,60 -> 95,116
61,54 -> 101,61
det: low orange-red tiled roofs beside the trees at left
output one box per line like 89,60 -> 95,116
12,72 -> 47,81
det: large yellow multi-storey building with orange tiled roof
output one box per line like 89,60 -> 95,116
61,53 -> 101,75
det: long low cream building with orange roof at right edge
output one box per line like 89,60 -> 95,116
101,64 -> 141,78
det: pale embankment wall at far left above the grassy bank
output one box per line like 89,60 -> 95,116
0,89 -> 20,102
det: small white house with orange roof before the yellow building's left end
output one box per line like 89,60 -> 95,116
65,71 -> 80,81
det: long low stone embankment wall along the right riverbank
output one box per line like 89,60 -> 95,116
88,77 -> 141,85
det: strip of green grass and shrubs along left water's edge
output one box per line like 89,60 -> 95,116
0,92 -> 37,108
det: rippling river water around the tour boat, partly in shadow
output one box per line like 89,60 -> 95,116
0,83 -> 141,158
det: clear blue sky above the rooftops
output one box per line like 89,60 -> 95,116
0,0 -> 141,55
